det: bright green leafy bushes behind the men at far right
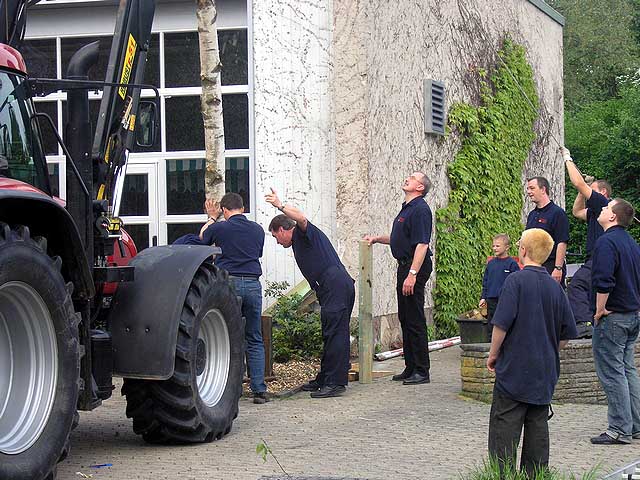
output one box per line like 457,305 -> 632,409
565,84 -> 640,260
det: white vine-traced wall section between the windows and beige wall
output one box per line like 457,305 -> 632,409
253,0 -> 335,296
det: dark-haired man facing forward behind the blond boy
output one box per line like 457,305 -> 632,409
526,177 -> 569,287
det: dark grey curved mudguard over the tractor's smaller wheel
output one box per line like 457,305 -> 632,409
109,245 -> 221,380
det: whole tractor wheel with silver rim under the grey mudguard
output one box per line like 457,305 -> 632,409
122,263 -> 244,444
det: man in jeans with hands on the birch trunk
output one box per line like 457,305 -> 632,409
200,193 -> 268,404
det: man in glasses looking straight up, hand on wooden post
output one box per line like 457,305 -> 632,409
364,172 -> 433,385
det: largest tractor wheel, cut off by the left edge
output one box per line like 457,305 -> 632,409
0,222 -> 80,480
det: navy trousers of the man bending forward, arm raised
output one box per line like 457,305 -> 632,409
315,266 -> 356,385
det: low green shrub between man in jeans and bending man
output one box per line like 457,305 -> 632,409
265,282 -> 322,363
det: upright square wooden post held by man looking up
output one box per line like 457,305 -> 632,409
358,240 -> 373,383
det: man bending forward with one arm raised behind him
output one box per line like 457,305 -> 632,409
265,189 -> 356,398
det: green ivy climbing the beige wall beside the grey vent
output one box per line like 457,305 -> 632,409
434,39 -> 538,337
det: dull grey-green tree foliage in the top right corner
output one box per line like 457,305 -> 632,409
548,0 -> 640,112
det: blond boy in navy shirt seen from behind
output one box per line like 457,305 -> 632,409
487,228 -> 576,477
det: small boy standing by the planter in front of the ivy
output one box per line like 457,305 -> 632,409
479,233 -> 520,321
